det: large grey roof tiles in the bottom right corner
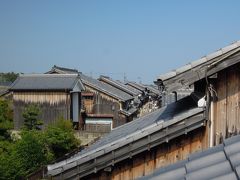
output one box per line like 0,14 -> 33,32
140,135 -> 240,180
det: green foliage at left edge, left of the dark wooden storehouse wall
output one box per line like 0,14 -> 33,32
0,98 -> 13,139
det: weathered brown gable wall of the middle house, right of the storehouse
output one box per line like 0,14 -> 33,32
83,85 -> 127,128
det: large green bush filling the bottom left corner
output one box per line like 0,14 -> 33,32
0,130 -> 53,179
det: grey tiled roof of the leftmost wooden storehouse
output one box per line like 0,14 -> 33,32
10,74 -> 84,91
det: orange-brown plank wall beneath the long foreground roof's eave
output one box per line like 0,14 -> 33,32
83,127 -> 208,180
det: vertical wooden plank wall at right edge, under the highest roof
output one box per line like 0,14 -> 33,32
214,64 -> 240,144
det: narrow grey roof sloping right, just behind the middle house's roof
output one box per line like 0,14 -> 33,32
99,76 -> 141,96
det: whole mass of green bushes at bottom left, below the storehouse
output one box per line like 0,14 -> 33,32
0,118 -> 80,180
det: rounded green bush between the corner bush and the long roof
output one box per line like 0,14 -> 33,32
45,118 -> 80,158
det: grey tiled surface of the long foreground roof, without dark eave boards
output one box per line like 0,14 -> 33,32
48,96 -> 203,176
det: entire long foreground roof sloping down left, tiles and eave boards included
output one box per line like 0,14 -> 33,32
48,96 -> 205,178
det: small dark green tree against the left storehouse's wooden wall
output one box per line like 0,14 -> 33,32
22,104 -> 43,130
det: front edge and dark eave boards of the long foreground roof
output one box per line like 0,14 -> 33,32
48,108 -> 205,179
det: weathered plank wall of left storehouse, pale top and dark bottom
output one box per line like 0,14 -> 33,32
13,92 -> 71,129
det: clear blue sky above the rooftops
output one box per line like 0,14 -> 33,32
0,0 -> 240,84
